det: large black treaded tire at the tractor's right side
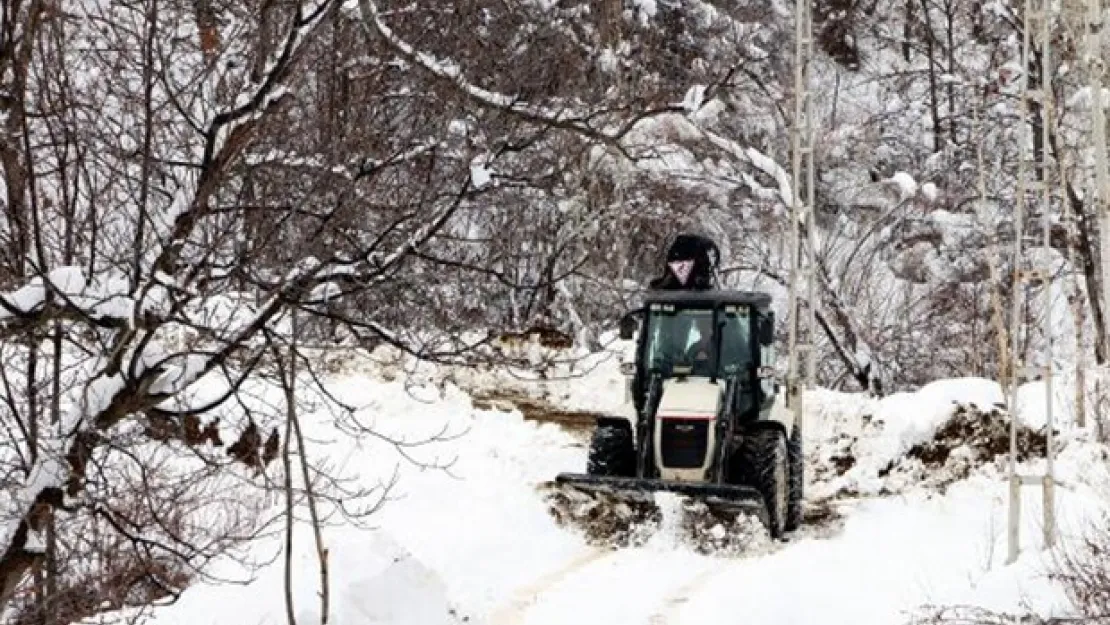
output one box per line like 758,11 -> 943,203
735,429 -> 790,541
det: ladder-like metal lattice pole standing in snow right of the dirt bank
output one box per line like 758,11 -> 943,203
1007,0 -> 1058,563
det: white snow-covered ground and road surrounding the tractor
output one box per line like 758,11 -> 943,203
95,341 -> 1106,625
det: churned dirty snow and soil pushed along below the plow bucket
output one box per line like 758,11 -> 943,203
541,482 -> 770,556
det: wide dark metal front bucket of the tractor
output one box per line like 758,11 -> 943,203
555,473 -> 768,525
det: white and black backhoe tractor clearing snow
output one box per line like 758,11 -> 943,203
555,235 -> 804,540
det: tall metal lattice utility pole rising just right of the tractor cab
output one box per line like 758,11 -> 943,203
787,0 -> 817,461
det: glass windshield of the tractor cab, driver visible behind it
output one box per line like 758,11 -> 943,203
644,305 -> 751,377
